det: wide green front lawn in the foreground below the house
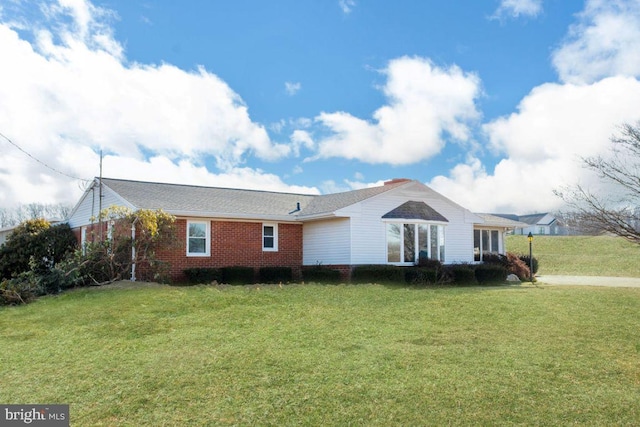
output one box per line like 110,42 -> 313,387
0,284 -> 640,426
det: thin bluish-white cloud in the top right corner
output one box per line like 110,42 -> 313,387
553,0 -> 640,83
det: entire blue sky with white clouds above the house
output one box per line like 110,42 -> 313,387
0,0 -> 640,214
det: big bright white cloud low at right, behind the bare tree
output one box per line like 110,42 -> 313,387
430,77 -> 640,213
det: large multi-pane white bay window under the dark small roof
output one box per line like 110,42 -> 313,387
387,222 -> 445,264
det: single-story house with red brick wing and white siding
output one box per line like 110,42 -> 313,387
69,178 -> 513,280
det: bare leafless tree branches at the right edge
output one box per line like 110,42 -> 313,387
556,122 -> 640,244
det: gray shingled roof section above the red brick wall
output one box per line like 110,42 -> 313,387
102,178 -> 318,216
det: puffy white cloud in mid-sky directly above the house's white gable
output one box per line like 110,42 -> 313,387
315,57 -> 481,165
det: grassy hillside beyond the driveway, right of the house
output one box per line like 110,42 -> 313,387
507,236 -> 640,277
